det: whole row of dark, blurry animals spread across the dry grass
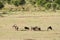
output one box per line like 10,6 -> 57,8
12,24 -> 53,31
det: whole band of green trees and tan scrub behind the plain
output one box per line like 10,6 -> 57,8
0,0 -> 60,11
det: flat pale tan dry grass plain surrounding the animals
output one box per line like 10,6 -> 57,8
0,11 -> 60,40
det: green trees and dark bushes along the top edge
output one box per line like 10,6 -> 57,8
0,0 -> 60,10
